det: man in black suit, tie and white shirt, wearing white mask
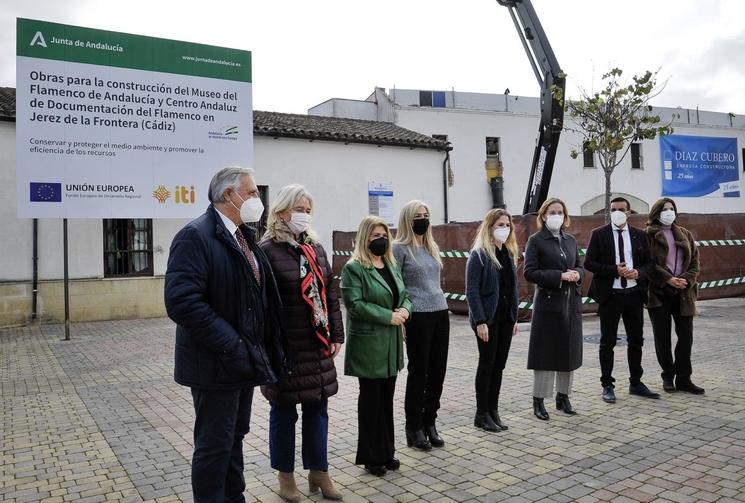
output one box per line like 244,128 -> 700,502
585,197 -> 660,403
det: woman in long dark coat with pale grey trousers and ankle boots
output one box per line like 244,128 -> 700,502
523,198 -> 585,420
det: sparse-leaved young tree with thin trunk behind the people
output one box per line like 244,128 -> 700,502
557,68 -> 673,221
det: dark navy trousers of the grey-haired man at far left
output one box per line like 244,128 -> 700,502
191,388 -> 253,503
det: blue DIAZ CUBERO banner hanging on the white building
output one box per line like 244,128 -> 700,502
660,135 -> 740,197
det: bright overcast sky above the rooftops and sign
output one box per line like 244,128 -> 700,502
0,0 -> 745,115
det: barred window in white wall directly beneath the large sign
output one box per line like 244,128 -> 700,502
103,218 -> 153,278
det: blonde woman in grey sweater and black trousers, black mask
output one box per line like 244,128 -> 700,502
393,200 -> 450,451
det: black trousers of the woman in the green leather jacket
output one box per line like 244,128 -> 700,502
354,376 -> 396,465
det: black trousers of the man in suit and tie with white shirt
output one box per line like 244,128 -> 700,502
598,291 -> 644,386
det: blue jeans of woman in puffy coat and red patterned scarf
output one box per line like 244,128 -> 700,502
269,398 -> 329,472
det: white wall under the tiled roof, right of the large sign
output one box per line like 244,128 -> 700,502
254,136 -> 445,254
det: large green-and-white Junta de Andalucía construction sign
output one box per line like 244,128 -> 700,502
16,19 -> 253,218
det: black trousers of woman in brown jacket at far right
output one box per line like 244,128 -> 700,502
649,295 -> 693,379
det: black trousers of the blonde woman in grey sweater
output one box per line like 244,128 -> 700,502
404,309 -> 450,430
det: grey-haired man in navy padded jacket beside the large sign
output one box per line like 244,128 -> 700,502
165,167 -> 286,502
